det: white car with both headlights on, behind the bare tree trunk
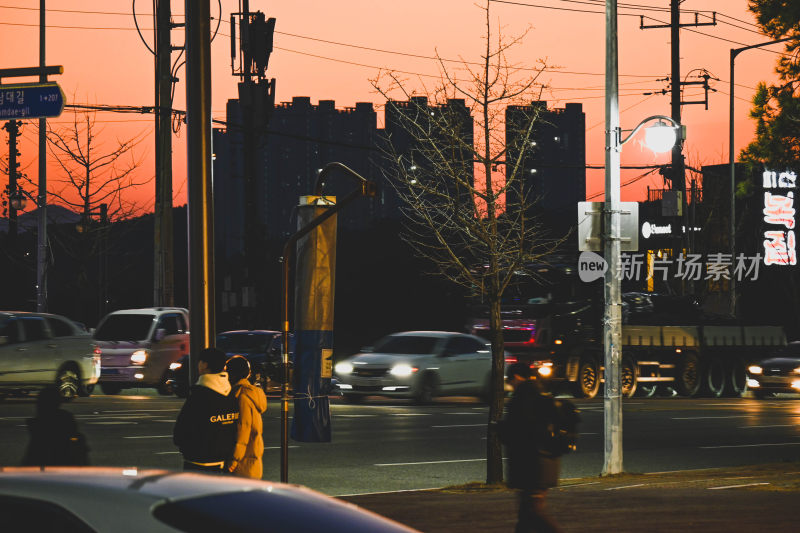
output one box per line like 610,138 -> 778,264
335,331 -> 492,403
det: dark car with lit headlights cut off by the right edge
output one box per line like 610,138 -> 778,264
747,342 -> 800,398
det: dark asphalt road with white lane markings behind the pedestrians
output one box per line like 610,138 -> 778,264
0,390 -> 800,496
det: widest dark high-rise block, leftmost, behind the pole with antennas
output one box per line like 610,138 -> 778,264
214,96 -> 377,249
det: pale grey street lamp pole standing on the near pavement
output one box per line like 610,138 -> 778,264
603,0 -> 622,475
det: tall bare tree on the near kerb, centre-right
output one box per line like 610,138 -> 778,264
371,2 -> 563,483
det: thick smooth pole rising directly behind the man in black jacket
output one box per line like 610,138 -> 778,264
185,0 -> 216,383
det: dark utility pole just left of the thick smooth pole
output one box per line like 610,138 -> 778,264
153,0 -> 175,306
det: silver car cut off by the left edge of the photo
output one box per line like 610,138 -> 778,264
0,311 -> 100,400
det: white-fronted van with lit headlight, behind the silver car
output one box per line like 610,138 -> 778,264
94,307 -> 189,394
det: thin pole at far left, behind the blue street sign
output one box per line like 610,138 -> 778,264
36,0 -> 47,313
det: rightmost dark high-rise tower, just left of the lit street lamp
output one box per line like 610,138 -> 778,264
505,101 -> 586,242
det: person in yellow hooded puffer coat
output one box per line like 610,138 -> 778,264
225,355 -> 267,479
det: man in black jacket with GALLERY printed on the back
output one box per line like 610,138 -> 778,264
172,348 -> 239,473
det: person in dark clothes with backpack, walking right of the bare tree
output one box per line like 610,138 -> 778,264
500,363 -> 561,533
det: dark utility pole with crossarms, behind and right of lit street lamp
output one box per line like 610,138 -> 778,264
639,0 -> 717,278
